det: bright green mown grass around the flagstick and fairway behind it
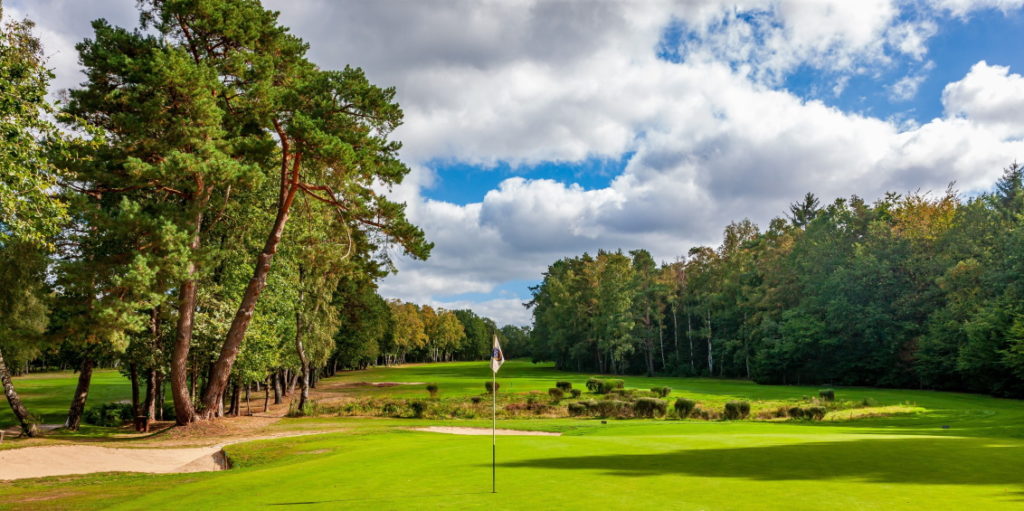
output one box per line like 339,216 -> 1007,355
0,361 -> 1024,510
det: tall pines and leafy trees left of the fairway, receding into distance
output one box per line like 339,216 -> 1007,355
0,0 -> 512,434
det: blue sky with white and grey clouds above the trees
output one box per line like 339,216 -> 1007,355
4,0 -> 1024,325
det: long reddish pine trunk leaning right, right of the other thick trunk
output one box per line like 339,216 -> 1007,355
202,182 -> 300,417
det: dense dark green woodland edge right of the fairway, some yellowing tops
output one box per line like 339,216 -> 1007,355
527,168 -> 1024,397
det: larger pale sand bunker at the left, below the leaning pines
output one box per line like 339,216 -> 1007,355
0,445 -> 227,479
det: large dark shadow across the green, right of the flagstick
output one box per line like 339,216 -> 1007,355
500,437 -> 1024,488
